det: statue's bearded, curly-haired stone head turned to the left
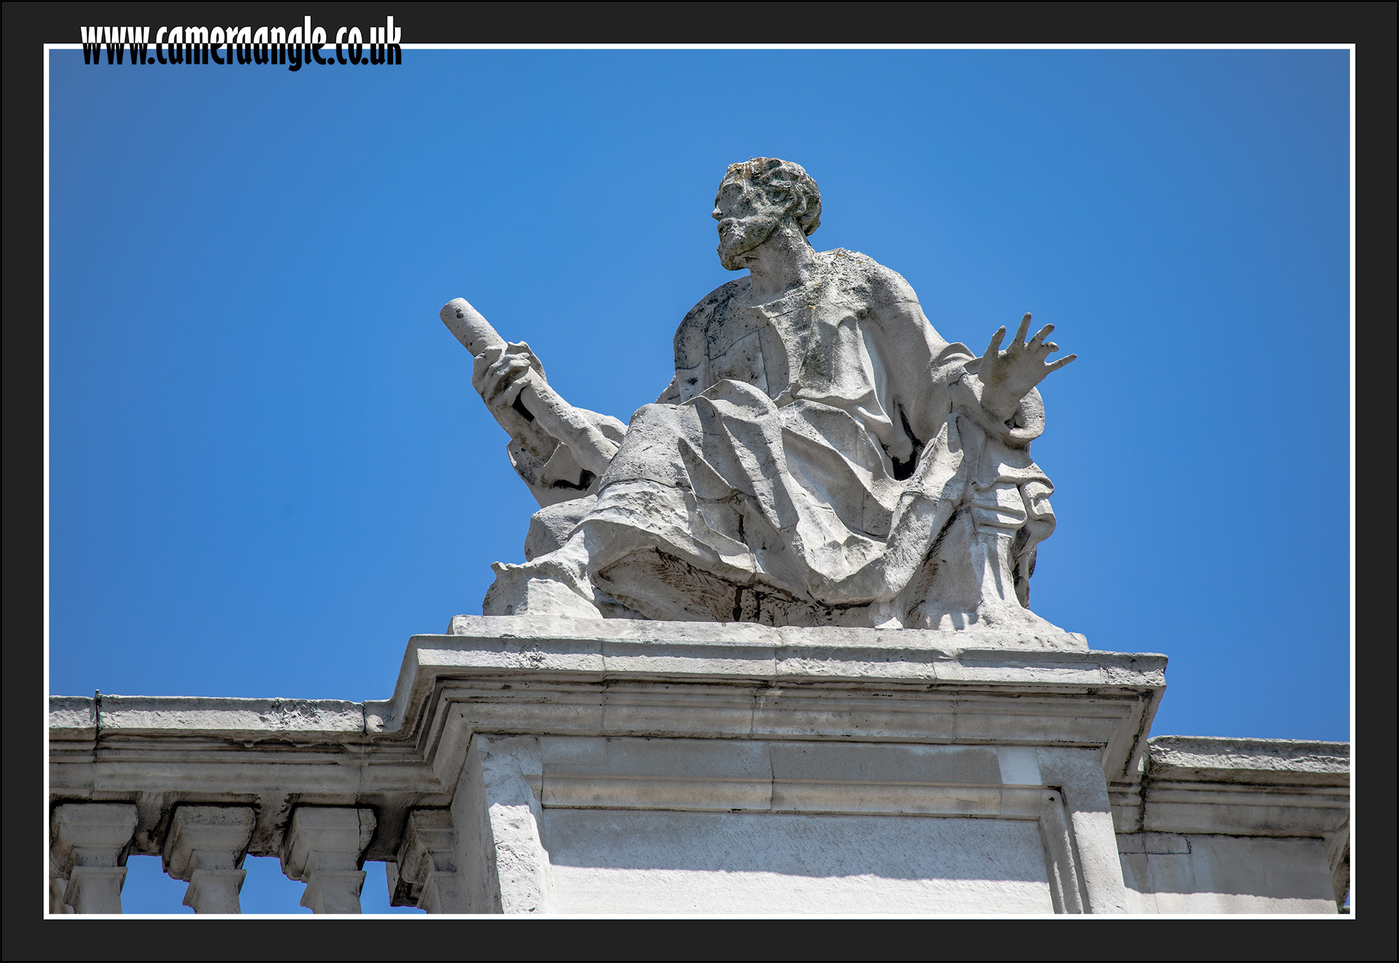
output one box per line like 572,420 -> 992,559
713,157 -> 821,270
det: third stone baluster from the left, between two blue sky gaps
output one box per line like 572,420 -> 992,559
281,806 -> 375,913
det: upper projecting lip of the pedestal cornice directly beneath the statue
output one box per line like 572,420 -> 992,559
380,616 -> 1167,732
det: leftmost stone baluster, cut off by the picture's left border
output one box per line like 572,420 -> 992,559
50,802 -> 136,913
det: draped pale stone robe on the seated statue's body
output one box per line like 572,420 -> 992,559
500,251 -> 1053,624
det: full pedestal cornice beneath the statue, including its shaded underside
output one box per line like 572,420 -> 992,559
377,616 -> 1165,783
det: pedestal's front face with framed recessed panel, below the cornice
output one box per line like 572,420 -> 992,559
459,735 -> 1122,914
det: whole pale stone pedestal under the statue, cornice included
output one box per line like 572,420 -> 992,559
380,617 -> 1165,914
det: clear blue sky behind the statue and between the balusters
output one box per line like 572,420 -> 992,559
49,49 -> 1350,911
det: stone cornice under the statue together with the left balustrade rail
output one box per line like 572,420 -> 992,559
49,616 -> 1165,783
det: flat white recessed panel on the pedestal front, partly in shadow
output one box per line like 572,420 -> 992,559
544,809 -> 1053,915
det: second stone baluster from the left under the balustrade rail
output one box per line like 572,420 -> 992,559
161,806 -> 253,913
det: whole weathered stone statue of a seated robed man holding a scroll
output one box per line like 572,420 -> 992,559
442,158 -> 1074,634
